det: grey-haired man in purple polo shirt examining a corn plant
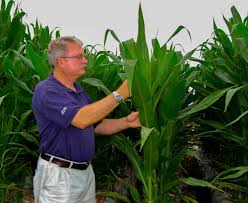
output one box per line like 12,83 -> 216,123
32,36 -> 140,203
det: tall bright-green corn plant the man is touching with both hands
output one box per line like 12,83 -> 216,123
99,3 -> 227,203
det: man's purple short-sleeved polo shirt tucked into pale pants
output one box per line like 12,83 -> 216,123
32,74 -> 95,162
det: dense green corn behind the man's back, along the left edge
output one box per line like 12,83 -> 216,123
0,0 -> 58,202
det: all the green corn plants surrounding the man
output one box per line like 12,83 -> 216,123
0,0 -> 248,203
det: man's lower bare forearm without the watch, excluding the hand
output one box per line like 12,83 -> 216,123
95,117 -> 129,135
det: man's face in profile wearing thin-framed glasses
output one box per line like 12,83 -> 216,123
59,43 -> 88,79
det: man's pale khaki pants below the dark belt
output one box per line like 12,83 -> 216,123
33,157 -> 96,203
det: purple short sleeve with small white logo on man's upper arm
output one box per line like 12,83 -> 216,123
40,90 -> 82,128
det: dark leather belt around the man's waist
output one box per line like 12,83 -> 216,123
41,153 -> 90,170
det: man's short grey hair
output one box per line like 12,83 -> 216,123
47,36 -> 83,67
